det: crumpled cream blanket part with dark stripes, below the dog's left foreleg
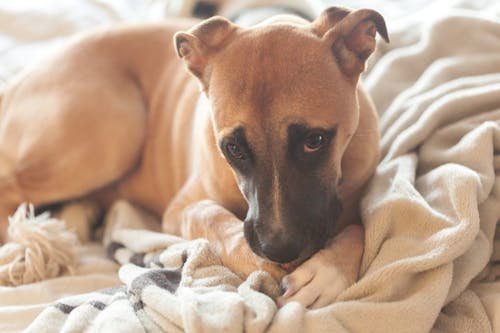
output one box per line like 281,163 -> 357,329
26,202 -> 284,333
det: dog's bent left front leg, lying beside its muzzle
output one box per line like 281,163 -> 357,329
181,200 -> 286,281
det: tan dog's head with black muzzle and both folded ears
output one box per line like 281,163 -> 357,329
175,7 -> 388,263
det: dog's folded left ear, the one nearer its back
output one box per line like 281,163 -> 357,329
174,16 -> 236,92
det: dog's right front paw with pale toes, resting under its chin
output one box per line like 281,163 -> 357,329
278,225 -> 364,309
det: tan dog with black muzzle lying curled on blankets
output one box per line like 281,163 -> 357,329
0,7 -> 388,308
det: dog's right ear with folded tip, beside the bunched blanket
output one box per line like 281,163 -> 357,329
313,7 -> 389,80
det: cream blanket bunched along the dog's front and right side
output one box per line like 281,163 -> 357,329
0,2 -> 500,332
